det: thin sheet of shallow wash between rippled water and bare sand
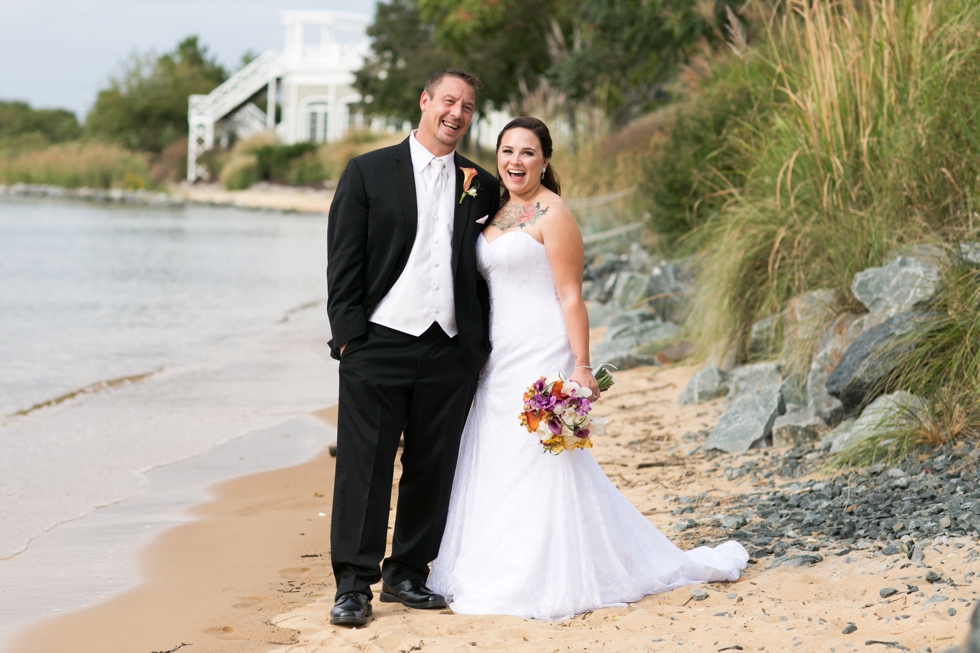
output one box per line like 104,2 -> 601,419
0,410 -> 335,651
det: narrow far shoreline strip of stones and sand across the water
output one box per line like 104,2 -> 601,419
0,184 -> 333,213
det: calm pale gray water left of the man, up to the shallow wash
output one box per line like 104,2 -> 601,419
0,200 -> 336,564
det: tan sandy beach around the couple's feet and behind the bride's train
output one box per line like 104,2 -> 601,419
12,366 -> 980,653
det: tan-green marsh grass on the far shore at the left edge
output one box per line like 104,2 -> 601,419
0,143 -> 150,190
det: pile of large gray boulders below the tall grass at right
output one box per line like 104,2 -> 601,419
680,247 -> 948,453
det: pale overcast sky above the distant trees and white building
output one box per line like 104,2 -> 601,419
0,0 -> 376,118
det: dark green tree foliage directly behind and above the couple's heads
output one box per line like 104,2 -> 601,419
357,0 -> 744,125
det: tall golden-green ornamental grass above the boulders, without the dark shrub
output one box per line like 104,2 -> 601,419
692,0 -> 980,354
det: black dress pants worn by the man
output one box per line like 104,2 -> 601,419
330,323 -> 477,597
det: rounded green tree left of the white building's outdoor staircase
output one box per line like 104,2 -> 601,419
85,36 -> 228,152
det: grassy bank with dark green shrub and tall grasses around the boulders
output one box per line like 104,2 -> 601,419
643,0 -> 980,464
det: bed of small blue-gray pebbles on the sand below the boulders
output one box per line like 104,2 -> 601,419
688,443 -> 980,556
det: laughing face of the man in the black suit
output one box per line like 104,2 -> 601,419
418,75 -> 476,154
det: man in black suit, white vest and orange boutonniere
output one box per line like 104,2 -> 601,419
327,70 -> 500,626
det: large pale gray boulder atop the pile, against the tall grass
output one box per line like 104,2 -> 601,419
851,252 -> 939,318
